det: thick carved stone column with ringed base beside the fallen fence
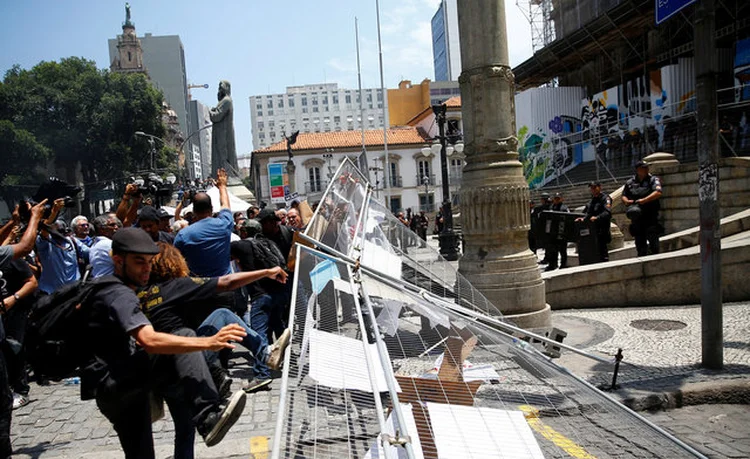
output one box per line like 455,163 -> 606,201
458,0 -> 550,328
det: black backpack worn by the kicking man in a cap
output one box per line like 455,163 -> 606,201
25,276 -> 120,381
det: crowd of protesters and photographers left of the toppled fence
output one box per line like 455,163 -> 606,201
0,170 -> 303,458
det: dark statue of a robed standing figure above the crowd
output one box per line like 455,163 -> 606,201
210,80 -> 238,177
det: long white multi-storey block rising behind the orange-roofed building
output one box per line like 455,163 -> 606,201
250,83 -> 386,150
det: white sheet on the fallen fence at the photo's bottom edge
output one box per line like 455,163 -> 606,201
427,402 -> 544,459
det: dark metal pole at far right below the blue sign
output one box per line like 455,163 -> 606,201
694,0 -> 724,369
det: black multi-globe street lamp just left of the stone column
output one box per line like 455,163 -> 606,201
423,104 -> 463,261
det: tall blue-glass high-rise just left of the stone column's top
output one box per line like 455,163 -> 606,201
431,0 -> 461,81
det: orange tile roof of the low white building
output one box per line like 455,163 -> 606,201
253,127 -> 426,153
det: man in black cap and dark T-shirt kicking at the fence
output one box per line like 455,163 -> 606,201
81,228 -> 245,459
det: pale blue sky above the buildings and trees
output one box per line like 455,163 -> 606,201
0,0 -> 531,155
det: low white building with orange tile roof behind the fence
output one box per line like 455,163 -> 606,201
250,97 -> 464,212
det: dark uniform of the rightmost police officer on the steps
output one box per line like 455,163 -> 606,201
622,174 -> 662,257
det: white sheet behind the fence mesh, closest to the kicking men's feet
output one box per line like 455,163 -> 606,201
309,329 -> 401,392
